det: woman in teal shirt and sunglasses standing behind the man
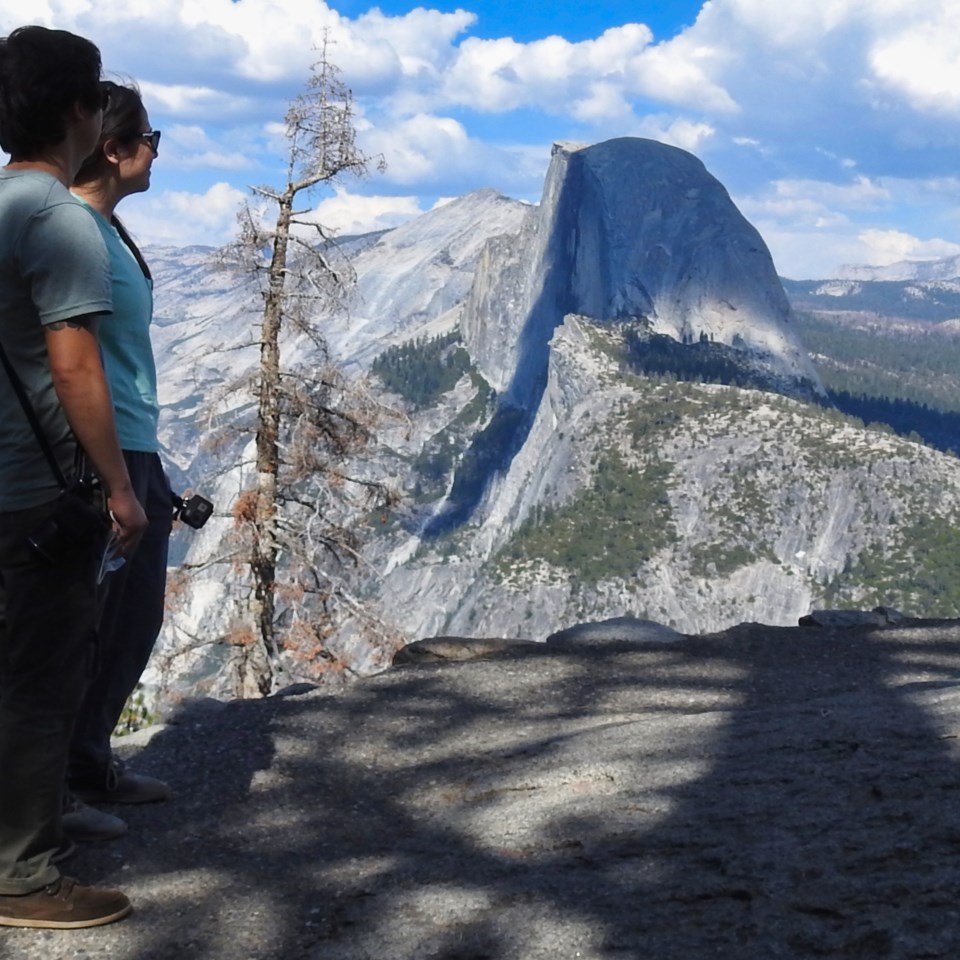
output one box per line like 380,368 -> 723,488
64,81 -> 172,840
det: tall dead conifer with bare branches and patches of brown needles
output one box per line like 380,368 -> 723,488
214,39 -> 392,695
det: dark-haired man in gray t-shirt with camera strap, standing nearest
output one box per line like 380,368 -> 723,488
0,27 -> 147,928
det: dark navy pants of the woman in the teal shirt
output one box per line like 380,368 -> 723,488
68,450 -> 173,788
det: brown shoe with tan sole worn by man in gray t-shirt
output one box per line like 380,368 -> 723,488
0,877 -> 133,929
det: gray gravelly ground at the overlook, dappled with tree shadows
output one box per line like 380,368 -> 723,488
9,620 -> 960,960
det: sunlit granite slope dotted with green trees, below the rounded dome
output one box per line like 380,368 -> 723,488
366,318 -> 960,637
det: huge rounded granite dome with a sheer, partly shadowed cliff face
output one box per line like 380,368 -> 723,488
461,137 -> 823,409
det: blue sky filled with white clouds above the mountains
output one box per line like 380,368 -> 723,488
0,0 -> 960,278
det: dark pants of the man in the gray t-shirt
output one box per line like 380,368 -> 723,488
0,504 -> 102,894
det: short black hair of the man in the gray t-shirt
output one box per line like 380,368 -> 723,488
0,26 -> 101,160
